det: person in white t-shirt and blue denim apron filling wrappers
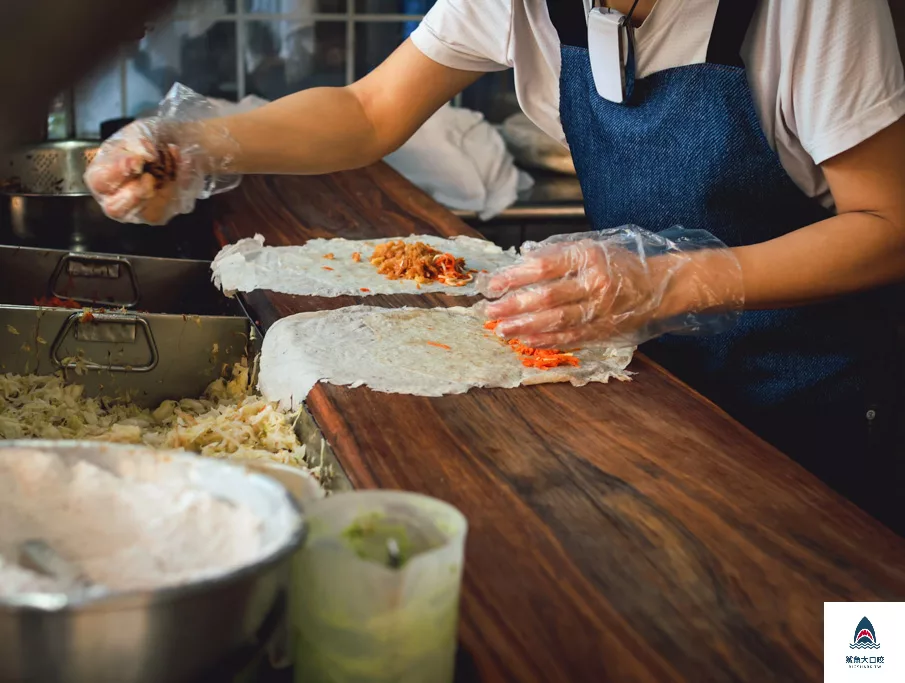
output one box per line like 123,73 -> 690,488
88,0 -> 905,524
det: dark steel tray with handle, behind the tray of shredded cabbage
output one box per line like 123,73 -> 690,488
0,243 -> 237,315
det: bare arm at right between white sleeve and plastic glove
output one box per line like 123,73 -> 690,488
673,118 -> 905,316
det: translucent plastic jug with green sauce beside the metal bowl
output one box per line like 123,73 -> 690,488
292,491 -> 468,683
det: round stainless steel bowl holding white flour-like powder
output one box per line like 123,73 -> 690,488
0,441 -> 305,683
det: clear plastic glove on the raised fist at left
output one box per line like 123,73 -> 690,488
85,83 -> 239,225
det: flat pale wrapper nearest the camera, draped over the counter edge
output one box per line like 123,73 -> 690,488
259,306 -> 634,408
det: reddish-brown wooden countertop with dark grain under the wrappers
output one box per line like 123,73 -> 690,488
216,165 -> 905,683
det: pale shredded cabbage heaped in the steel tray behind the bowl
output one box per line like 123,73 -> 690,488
0,363 -> 320,476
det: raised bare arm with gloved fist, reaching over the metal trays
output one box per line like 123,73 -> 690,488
86,40 -> 481,225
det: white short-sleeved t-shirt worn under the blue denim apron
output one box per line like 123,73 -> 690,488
412,0 -> 905,208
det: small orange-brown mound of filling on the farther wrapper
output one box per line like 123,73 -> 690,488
370,240 -> 477,287
